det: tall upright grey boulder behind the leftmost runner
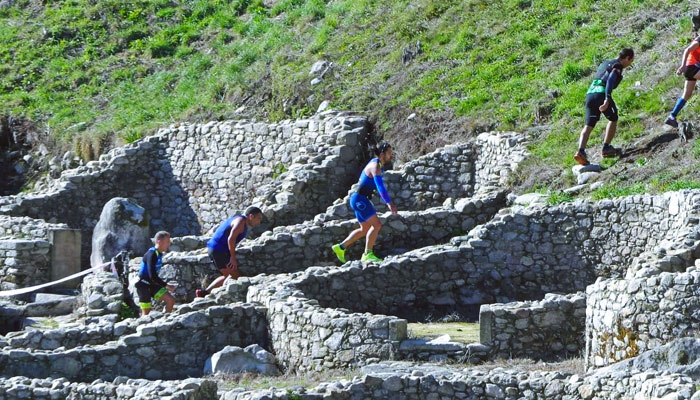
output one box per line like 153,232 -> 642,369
90,197 -> 152,267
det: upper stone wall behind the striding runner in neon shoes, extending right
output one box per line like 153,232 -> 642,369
316,132 -> 527,221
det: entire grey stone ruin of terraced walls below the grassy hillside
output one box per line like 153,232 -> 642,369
0,112 -> 700,400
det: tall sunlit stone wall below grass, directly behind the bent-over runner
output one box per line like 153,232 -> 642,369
158,112 -> 367,233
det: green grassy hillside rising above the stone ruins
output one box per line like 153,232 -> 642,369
0,0 -> 700,195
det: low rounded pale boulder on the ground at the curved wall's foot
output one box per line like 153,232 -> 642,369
204,344 -> 280,375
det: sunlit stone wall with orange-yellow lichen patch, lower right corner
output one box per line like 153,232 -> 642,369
586,268 -> 700,369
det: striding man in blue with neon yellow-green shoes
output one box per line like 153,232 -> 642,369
332,142 -> 398,263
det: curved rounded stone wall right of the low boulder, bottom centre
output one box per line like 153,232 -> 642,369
245,268 -> 407,371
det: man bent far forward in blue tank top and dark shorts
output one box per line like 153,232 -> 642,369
195,207 -> 263,297
